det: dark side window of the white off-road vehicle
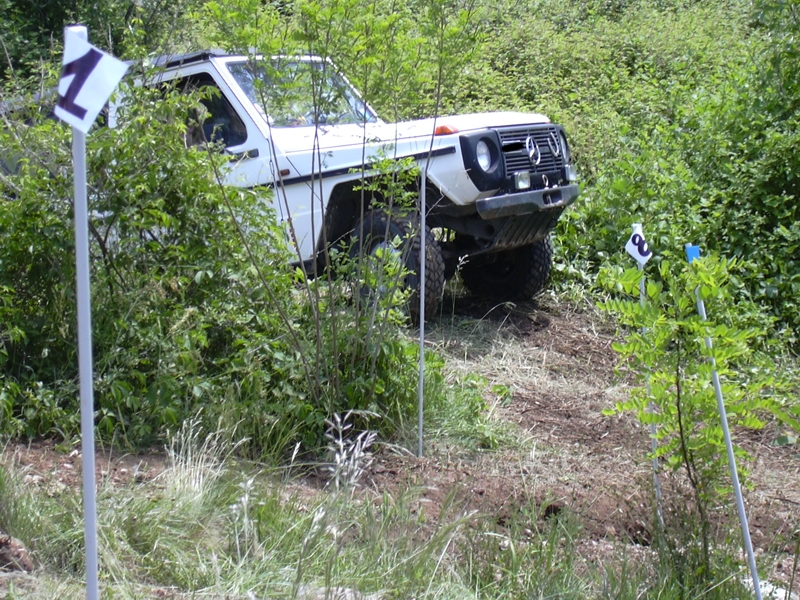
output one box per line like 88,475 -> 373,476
177,75 -> 247,147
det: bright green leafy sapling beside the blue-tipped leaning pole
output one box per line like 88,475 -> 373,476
600,257 -> 800,573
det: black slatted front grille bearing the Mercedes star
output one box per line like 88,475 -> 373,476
497,125 -> 564,177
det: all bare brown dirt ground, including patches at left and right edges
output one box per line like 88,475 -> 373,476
2,299 -> 800,592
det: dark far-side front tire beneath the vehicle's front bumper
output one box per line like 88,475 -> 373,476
461,236 -> 553,301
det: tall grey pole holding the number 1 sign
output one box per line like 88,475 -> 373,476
65,26 -> 98,600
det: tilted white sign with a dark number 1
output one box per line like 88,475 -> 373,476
54,29 -> 128,133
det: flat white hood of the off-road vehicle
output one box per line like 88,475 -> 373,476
271,112 -> 550,154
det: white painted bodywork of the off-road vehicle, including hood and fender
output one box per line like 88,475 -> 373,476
110,54 -> 577,260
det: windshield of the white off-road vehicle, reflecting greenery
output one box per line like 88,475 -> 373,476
222,59 -> 378,127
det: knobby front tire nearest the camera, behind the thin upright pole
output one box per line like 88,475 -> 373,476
351,210 -> 444,323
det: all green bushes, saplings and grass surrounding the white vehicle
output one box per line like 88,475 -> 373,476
0,0 -> 800,600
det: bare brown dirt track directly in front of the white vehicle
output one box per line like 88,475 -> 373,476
371,298 -> 649,542
